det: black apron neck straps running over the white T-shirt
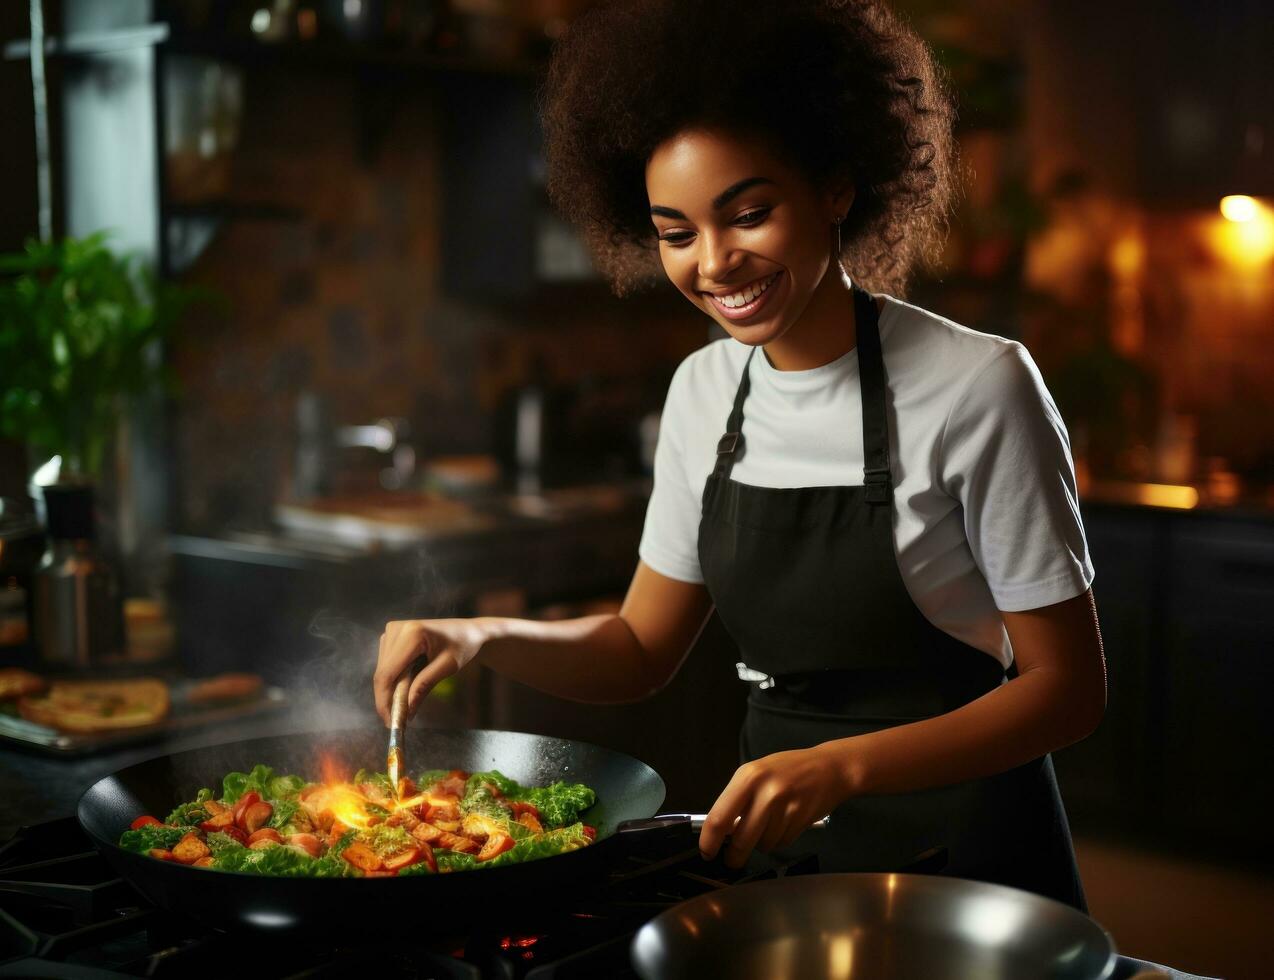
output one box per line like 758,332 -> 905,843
712,285 -> 893,503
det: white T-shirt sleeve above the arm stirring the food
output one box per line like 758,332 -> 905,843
637,362 -> 703,584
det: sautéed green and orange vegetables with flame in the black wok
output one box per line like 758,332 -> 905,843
120,766 -> 596,878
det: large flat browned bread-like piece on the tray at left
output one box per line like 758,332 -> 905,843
18,677 -> 169,733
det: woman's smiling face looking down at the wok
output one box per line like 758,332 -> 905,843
646,124 -> 854,345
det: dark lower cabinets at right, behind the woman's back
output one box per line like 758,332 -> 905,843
1055,506 -> 1274,856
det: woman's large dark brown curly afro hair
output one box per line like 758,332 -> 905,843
540,0 -> 956,296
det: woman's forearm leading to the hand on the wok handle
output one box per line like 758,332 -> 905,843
820,669 -> 1103,796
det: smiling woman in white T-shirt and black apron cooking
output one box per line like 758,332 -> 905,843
375,0 -> 1106,909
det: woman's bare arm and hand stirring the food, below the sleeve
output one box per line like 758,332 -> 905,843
373,562 -> 712,719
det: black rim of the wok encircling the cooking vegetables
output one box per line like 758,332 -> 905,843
75,726 -> 668,888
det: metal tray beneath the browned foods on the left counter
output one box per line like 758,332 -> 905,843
0,683 -> 288,757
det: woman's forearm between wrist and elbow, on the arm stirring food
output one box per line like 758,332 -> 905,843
475,613 -> 668,703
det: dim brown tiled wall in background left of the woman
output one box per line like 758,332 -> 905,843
175,69 -> 707,528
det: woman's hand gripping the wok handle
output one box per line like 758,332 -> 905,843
699,742 -> 852,868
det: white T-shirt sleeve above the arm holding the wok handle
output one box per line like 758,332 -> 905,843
939,343 -> 1093,612
